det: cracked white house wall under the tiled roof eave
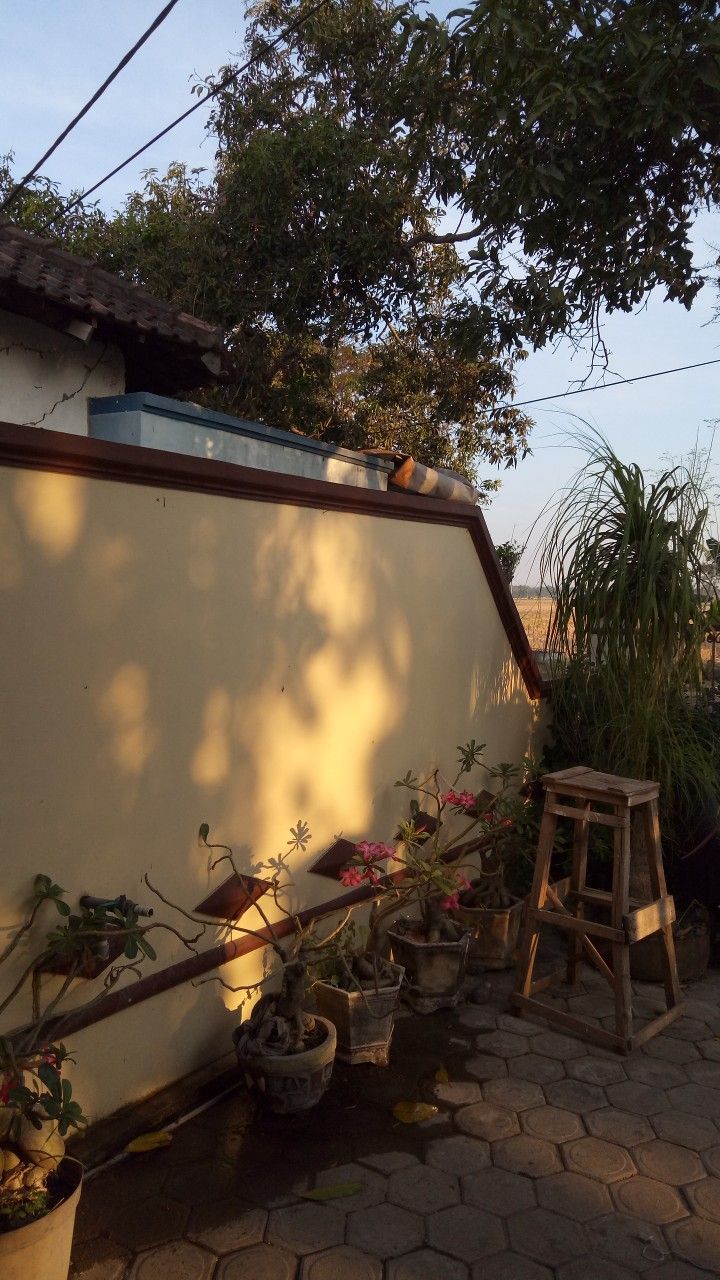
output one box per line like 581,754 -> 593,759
0,310 -> 126,435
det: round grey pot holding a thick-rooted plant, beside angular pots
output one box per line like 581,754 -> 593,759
237,1015 -> 337,1115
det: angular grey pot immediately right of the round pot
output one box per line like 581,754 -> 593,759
315,965 -> 405,1066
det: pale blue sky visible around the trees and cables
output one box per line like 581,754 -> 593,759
0,0 -> 720,582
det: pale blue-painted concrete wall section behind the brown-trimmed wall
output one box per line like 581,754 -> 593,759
90,392 -> 393,490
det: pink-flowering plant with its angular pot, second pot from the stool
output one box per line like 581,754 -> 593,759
333,740 -> 525,1012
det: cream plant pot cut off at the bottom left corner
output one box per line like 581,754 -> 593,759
0,1156 -> 82,1280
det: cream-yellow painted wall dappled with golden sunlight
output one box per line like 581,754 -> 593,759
0,468 -> 537,1117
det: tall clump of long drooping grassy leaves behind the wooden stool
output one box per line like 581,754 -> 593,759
541,435 -> 720,851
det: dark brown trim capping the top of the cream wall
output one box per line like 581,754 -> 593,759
0,422 -> 544,700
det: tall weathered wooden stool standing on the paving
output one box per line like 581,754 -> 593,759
511,765 -> 683,1053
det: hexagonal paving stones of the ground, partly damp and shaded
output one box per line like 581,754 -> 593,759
67,970 -> 720,1280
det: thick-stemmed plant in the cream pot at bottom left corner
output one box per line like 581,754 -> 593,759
0,876 -> 165,1280
